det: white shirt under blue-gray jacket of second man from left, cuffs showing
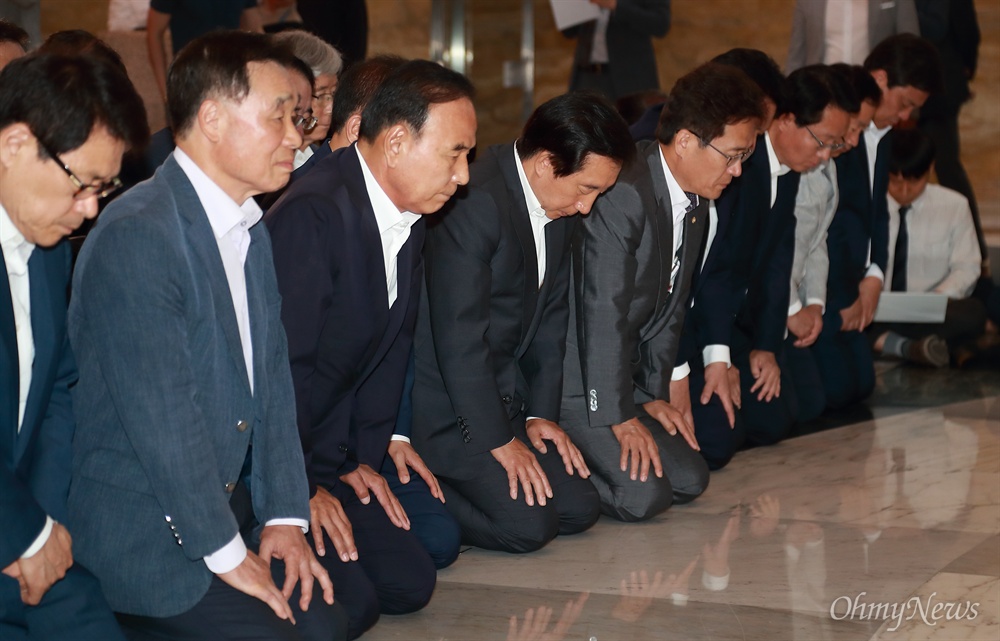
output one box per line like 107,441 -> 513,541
174,147 -> 309,574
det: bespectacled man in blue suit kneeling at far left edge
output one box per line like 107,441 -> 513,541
0,54 -> 147,640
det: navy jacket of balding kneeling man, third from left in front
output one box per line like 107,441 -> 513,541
264,145 -> 424,498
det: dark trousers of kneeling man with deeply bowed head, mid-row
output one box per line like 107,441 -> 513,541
438,439 -> 601,553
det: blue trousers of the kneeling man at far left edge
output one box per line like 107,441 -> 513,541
0,563 -> 125,641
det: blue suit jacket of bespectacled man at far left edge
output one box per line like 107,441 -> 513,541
0,242 -> 76,567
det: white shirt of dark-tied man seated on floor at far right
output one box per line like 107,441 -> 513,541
884,185 -> 982,298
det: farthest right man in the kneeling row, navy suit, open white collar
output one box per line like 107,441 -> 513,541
810,33 -> 943,409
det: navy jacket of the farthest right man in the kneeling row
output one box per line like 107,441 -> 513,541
823,135 -> 892,320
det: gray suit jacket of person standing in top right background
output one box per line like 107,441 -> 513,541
785,0 -> 920,73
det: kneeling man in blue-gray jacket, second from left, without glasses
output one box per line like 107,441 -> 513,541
69,31 -> 346,640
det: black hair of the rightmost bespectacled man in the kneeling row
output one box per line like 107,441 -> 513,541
774,65 -> 861,127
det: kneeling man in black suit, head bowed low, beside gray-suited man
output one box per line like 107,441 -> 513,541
413,92 -> 635,552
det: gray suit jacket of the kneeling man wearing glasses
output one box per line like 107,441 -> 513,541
560,141 -> 708,427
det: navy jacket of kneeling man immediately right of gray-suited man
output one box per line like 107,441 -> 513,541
685,135 -> 799,357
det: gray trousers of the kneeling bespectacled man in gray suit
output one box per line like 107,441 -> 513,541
562,402 -> 708,521
